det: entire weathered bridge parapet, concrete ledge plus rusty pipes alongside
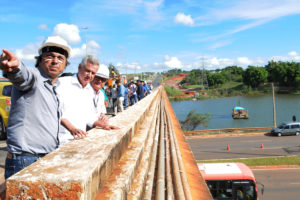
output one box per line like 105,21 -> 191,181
6,87 -> 212,200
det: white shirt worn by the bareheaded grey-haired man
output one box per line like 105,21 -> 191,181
57,74 -> 97,144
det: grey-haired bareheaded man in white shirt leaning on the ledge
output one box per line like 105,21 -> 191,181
57,55 -> 109,144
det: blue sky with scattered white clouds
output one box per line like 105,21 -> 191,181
0,0 -> 300,73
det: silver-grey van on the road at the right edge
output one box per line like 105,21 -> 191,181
271,122 -> 300,137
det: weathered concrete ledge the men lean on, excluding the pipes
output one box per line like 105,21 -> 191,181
6,90 -> 159,200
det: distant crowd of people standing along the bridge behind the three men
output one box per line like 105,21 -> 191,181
104,80 -> 153,115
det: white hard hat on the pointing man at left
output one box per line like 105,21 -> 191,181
39,36 -> 71,58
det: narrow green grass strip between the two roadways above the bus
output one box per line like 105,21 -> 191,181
197,156 -> 300,166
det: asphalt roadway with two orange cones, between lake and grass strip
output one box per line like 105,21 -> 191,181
187,135 -> 300,160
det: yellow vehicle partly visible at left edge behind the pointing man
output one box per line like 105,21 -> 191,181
0,78 -> 12,140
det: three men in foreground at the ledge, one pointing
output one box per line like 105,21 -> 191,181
0,36 -> 117,179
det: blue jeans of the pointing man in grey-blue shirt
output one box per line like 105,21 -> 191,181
5,154 -> 40,179
